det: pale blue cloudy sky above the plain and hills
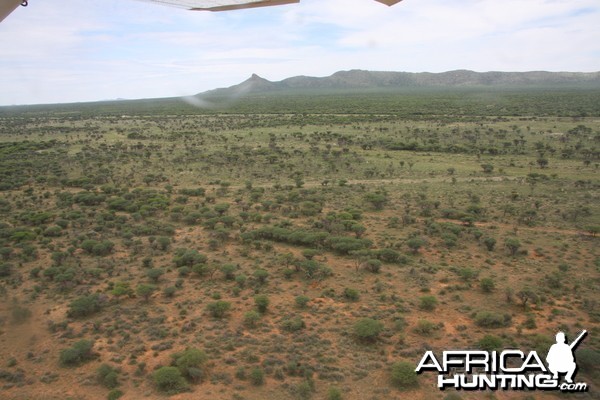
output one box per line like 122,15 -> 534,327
0,0 -> 600,105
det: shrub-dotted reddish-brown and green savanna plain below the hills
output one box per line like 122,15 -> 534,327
0,89 -> 600,399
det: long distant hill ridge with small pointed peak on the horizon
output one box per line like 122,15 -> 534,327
196,70 -> 600,98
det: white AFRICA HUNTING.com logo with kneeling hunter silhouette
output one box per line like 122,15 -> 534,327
415,330 -> 588,392
